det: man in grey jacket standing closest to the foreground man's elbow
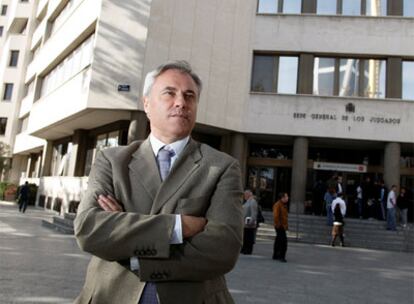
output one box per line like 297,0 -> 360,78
240,189 -> 258,254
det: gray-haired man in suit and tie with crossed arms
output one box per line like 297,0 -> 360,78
75,61 -> 243,304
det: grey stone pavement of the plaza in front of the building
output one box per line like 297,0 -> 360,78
0,202 -> 414,304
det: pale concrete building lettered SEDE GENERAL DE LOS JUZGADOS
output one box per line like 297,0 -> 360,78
2,0 -> 414,216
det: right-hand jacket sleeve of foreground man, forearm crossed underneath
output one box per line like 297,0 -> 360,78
140,161 -> 243,281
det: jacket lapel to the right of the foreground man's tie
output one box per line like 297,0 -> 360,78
151,139 -> 202,214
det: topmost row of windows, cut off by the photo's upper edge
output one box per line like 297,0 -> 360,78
257,0 -> 414,17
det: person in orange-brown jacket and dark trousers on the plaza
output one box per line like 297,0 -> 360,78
273,193 -> 289,263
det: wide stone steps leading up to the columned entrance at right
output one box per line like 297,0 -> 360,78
257,211 -> 414,252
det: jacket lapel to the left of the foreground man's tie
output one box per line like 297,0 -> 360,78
129,139 -> 161,201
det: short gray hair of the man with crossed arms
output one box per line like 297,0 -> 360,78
142,60 -> 203,96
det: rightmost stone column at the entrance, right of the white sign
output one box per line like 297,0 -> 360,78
384,143 -> 401,189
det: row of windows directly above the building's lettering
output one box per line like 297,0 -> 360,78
251,55 -> 414,100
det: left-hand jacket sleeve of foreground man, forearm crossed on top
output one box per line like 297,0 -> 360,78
74,153 -> 175,261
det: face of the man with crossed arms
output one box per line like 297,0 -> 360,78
144,70 -> 198,144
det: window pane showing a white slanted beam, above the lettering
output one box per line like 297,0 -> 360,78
339,59 -> 359,96
